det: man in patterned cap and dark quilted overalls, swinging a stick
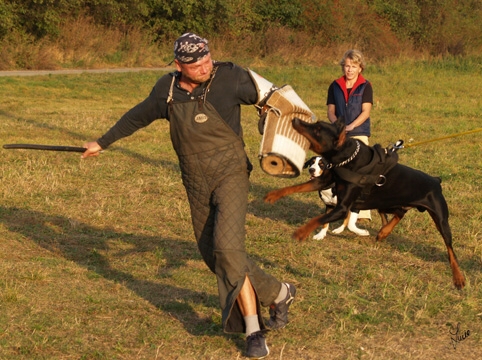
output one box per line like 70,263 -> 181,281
82,33 -> 296,358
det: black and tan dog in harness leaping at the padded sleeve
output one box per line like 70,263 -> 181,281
265,118 -> 465,289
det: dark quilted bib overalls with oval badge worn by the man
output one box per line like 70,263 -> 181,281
168,71 -> 281,332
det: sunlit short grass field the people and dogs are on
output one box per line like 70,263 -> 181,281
0,60 -> 482,360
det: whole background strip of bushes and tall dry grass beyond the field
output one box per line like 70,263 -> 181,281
0,0 -> 482,69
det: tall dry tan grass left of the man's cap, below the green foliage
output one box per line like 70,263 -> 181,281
0,18 -> 172,70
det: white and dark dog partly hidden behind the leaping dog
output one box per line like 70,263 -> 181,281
304,156 -> 370,240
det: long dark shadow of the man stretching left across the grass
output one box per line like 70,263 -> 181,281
0,206 -> 244,348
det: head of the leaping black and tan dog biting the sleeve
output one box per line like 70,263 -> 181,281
292,118 -> 346,155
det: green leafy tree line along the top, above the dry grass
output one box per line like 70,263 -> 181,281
0,0 -> 482,68
